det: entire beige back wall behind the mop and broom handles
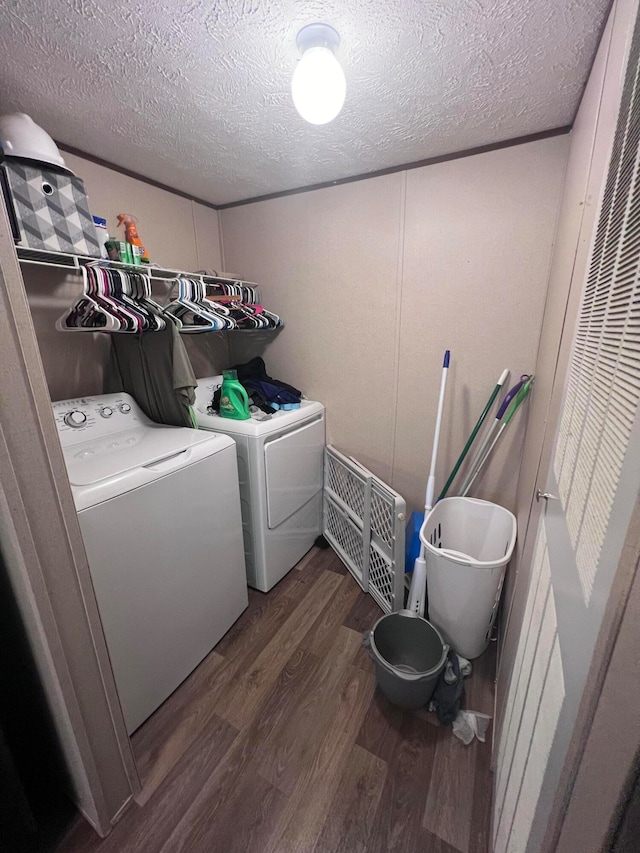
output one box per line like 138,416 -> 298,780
220,136 -> 568,508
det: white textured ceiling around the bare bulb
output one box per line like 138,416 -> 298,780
0,0 -> 609,204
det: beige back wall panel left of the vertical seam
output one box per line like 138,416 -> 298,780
228,175 -> 403,480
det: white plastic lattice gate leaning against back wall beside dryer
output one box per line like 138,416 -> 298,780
323,446 -> 406,613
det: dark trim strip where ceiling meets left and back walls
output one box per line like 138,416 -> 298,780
56,125 -> 571,210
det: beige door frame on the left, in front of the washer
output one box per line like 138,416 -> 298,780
0,198 -> 140,824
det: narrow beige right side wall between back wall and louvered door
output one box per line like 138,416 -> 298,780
494,0 -> 638,743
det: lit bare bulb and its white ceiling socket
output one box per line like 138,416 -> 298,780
291,24 -> 347,124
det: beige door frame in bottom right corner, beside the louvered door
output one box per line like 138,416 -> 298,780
542,493 -> 640,853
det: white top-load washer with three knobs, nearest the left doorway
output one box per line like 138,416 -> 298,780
53,393 -> 248,732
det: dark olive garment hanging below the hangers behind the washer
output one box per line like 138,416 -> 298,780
104,323 -> 197,427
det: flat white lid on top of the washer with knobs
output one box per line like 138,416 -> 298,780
64,425 -> 229,491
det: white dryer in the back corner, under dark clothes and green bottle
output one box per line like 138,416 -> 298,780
195,376 -> 325,592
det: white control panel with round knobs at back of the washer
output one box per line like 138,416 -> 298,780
52,392 -> 151,447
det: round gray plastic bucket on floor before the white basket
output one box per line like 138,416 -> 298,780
365,610 -> 449,710
